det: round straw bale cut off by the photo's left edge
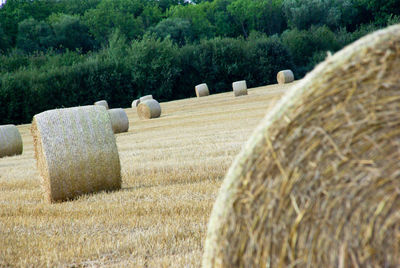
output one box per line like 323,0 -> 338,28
0,125 -> 23,157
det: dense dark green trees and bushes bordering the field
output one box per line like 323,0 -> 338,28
0,0 -> 400,124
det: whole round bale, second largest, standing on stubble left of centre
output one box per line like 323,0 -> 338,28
31,106 -> 121,202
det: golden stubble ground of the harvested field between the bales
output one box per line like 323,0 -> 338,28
0,84 -> 293,267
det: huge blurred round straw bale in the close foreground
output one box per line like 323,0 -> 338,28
203,25 -> 400,267
